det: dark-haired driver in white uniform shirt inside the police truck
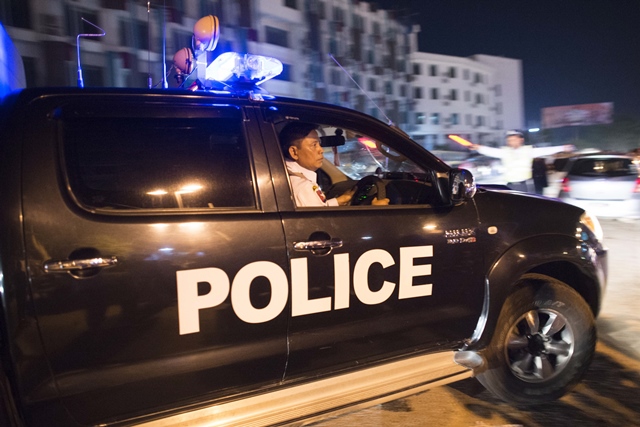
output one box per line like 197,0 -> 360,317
280,122 -> 389,207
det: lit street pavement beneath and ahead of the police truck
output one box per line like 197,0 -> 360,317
313,219 -> 640,427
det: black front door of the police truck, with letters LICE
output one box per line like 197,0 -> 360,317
260,106 -> 484,378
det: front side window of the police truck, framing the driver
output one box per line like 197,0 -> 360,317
280,122 -> 436,207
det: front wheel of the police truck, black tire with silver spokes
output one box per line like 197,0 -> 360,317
476,275 -> 596,405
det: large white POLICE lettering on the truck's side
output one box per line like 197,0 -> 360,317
176,246 -> 433,335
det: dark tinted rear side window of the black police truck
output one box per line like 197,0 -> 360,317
62,106 -> 256,211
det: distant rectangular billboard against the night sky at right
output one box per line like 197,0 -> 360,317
542,102 -> 613,129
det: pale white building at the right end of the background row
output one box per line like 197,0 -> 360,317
410,52 -> 524,149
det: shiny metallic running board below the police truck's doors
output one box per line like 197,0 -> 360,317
139,351 -> 472,427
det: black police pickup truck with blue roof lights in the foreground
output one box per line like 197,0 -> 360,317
0,47 -> 606,426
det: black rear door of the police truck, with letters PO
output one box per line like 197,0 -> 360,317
23,96 -> 288,425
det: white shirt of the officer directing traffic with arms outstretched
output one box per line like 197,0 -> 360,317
478,145 -> 564,182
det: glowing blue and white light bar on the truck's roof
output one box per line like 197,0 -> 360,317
206,52 -> 282,86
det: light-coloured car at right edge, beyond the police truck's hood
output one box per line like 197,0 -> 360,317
558,154 -> 640,218
